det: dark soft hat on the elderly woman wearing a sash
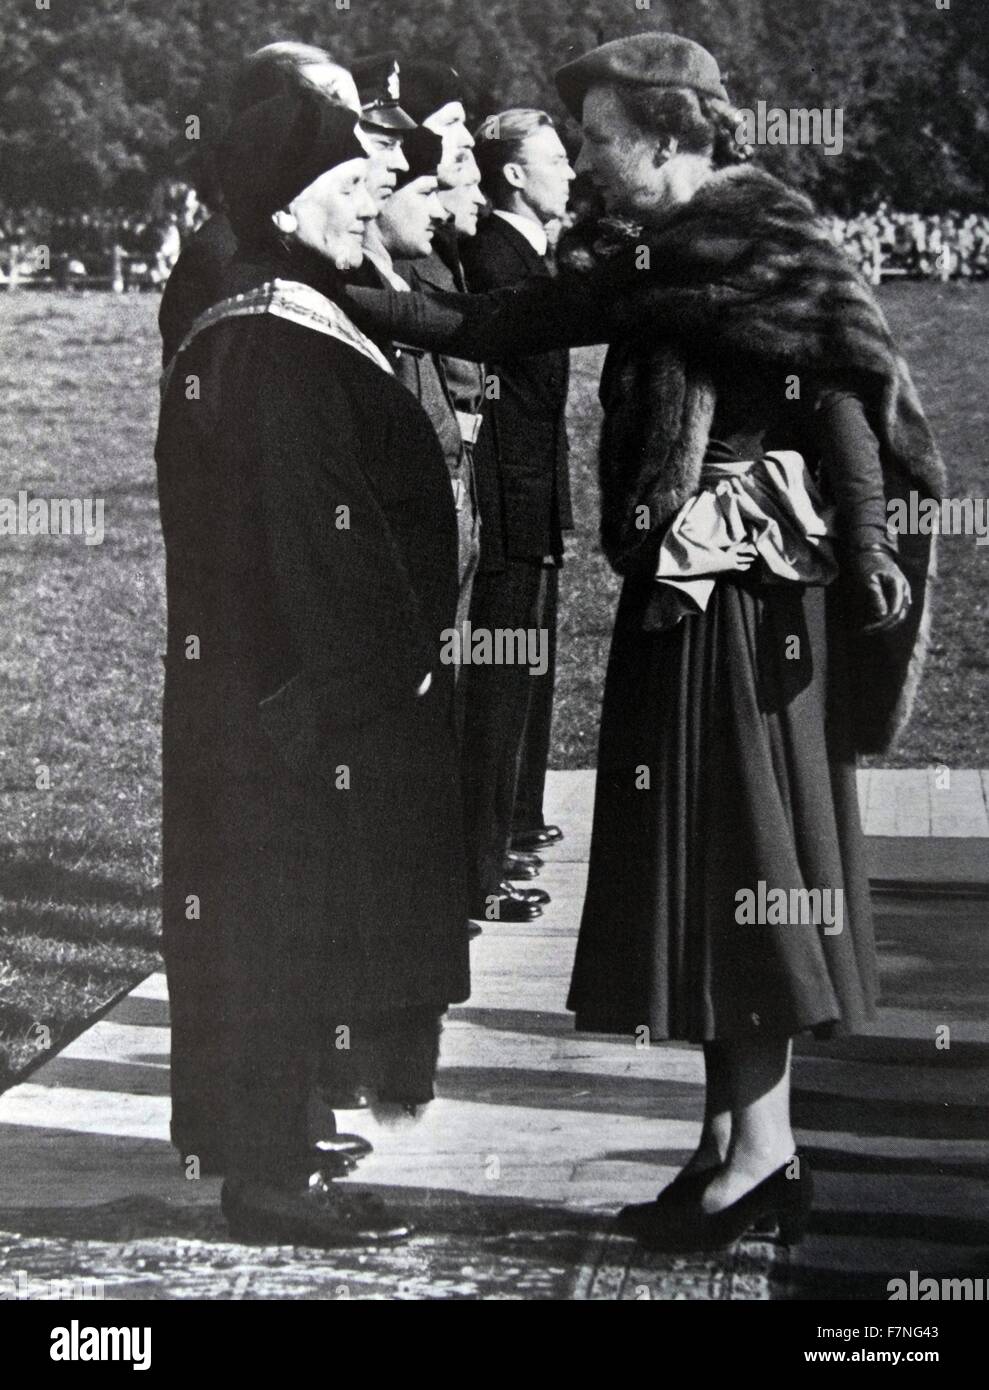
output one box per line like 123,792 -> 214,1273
217,89 -> 367,238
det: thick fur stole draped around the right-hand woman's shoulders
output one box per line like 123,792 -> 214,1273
560,165 -> 945,752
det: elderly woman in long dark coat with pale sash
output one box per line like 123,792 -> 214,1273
157,93 -> 468,1244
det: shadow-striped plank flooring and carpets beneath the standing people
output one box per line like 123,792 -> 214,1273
0,773 -> 989,1301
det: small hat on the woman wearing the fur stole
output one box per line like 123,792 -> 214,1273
556,33 -> 728,121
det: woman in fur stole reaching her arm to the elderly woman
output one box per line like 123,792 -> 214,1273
344,35 -> 943,1248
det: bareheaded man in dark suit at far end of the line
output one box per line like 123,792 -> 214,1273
461,110 -> 575,920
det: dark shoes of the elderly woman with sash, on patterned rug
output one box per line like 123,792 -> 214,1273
221,1173 -> 414,1250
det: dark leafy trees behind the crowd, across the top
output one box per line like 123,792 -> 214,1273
0,0 -> 989,211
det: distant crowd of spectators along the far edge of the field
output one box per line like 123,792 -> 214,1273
0,183 -> 989,289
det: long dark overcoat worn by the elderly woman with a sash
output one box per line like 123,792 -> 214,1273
157,241 -> 468,1152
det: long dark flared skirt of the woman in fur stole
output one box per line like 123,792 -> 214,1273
568,575 -> 875,1043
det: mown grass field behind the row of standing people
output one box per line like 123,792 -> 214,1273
0,285 -> 989,1087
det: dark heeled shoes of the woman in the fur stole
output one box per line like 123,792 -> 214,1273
638,1155 -> 814,1252
